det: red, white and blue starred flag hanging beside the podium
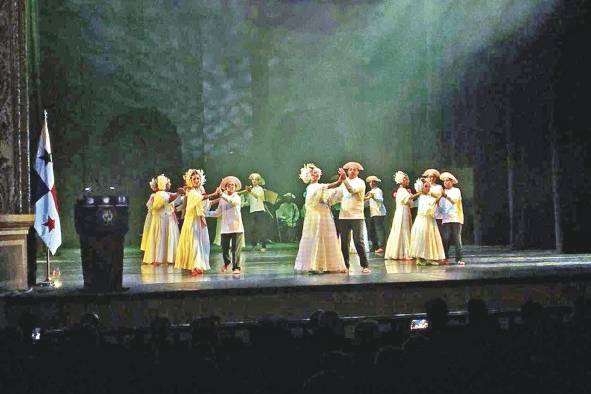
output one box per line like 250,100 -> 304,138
33,113 -> 62,254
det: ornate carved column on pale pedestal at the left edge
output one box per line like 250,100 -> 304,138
0,0 -> 33,290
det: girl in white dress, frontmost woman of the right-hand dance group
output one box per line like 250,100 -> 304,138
410,182 -> 445,265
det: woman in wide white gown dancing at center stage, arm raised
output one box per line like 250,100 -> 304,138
294,163 -> 347,273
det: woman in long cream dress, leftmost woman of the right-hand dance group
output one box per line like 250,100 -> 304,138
385,171 -> 420,260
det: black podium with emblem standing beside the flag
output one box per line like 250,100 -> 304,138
74,195 -> 129,292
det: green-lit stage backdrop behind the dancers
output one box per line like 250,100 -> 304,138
29,0 -> 556,246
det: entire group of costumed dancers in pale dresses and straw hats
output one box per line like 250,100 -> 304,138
141,162 -> 464,275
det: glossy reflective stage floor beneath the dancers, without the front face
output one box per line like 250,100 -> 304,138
33,244 -> 591,294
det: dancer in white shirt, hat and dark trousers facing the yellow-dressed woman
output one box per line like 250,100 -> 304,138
209,176 -> 244,274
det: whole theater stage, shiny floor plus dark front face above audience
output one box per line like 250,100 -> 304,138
0,244 -> 591,328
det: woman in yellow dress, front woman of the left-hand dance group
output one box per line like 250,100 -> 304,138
174,169 -> 219,276
